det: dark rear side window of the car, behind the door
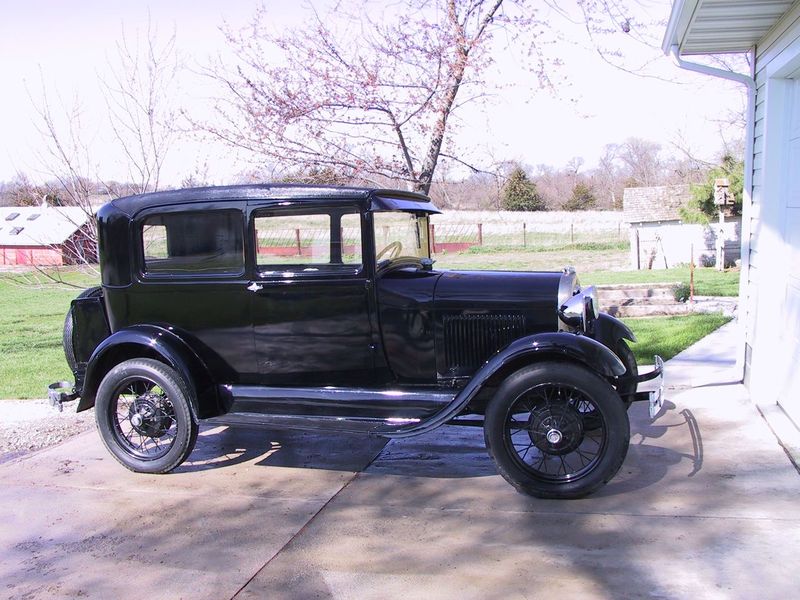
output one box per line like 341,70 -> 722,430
142,210 -> 244,275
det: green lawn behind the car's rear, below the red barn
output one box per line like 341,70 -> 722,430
0,273 -> 95,399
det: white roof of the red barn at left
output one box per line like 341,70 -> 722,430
0,205 -> 89,246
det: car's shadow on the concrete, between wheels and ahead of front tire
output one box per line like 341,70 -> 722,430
178,402 -> 703,495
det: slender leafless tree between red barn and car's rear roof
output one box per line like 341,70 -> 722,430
12,21 -> 178,284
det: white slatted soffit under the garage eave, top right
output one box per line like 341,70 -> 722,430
662,0 -> 796,55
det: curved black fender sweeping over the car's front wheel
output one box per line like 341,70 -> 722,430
384,332 -> 625,438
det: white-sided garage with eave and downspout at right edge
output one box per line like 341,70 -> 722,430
663,0 -> 800,426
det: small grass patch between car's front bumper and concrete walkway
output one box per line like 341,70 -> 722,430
624,313 -> 731,365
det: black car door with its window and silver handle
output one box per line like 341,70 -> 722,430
248,204 -> 378,387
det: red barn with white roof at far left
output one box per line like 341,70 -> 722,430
0,204 -> 97,266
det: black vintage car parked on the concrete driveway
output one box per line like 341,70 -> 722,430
51,185 -> 662,498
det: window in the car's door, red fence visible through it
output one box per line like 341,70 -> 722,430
255,209 -> 362,275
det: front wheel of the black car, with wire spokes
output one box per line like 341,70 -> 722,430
483,362 -> 630,498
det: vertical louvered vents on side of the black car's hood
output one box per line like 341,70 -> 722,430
444,315 -> 525,372
